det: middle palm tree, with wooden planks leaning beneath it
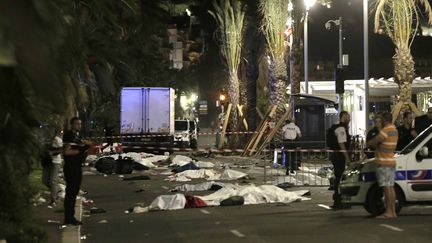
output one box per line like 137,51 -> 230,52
259,0 -> 288,116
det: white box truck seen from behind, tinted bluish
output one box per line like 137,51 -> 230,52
120,87 -> 175,153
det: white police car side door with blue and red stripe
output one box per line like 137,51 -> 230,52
404,127 -> 432,201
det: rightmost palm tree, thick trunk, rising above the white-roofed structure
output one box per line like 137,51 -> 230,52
374,0 -> 432,115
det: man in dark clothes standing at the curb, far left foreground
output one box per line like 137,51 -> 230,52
63,117 -> 88,225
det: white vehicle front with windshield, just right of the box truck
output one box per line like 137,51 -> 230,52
174,119 -> 198,148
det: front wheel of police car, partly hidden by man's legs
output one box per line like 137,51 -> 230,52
364,185 -> 405,216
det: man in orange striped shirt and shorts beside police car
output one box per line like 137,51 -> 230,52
368,112 -> 398,219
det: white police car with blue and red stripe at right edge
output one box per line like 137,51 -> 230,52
340,126 -> 432,215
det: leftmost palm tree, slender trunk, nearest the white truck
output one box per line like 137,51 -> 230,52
209,0 -> 245,142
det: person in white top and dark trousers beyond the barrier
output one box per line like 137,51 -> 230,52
282,118 -> 301,175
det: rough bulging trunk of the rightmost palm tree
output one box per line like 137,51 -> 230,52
393,47 -> 415,112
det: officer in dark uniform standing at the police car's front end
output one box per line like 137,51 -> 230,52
327,111 -> 351,209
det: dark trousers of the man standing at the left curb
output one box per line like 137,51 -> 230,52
63,161 -> 82,222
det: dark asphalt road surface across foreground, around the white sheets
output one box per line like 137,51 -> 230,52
81,160 -> 432,243
